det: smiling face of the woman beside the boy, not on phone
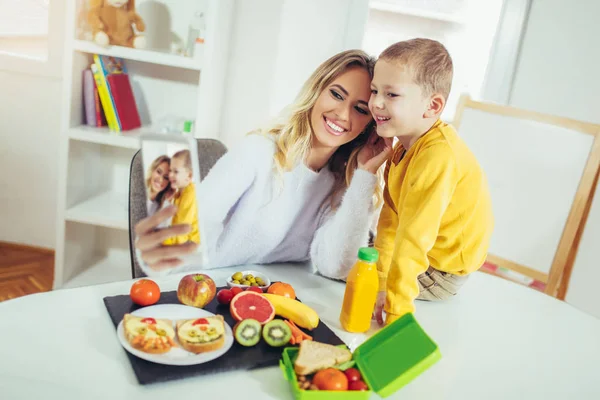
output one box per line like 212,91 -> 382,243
310,67 -> 372,148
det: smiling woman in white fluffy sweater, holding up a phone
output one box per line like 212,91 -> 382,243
136,50 -> 391,278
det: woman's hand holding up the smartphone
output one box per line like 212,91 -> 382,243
135,206 -> 198,271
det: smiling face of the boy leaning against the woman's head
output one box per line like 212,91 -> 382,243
369,60 -> 429,138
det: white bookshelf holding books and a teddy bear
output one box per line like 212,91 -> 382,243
54,0 -> 234,288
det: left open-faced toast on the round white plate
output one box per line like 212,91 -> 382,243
123,314 -> 175,354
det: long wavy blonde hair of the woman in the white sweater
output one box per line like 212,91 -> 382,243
251,50 -> 381,208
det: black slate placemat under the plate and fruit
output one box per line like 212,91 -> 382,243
104,288 -> 343,385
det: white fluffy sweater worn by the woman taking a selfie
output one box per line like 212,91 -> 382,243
140,135 -> 377,279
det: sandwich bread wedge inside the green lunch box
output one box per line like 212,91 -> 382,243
294,340 -> 352,375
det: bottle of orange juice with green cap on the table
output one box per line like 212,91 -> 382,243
340,247 -> 379,332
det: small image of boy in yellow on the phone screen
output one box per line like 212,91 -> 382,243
163,150 -> 200,245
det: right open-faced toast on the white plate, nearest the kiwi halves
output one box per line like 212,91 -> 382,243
177,315 -> 225,354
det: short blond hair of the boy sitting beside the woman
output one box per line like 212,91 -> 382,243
379,38 -> 454,100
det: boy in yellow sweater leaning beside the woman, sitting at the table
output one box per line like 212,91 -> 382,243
369,39 -> 493,325
